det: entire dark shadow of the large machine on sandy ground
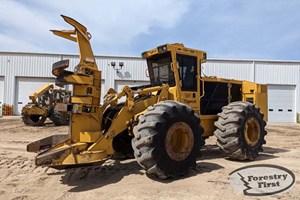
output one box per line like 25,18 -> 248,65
56,145 -> 288,192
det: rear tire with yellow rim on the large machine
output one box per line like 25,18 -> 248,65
214,101 -> 267,160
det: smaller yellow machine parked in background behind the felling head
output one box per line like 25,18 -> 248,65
21,83 -> 71,126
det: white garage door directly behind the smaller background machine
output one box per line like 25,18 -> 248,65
14,77 -> 54,115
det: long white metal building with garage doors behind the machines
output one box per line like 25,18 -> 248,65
0,52 -> 300,122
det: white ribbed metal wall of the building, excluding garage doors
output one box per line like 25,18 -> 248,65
0,52 -> 300,117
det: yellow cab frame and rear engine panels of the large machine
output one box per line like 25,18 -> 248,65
142,44 -> 268,137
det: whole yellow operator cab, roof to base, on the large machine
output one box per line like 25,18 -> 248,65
142,43 -> 206,111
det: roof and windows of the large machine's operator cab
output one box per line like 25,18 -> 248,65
142,43 -> 206,91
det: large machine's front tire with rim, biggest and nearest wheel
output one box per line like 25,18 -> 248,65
132,101 -> 204,179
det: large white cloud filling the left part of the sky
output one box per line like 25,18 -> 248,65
0,0 -> 190,54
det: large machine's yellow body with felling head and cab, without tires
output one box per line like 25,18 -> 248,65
27,16 -> 267,169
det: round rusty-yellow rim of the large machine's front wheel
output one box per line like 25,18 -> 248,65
165,122 -> 194,161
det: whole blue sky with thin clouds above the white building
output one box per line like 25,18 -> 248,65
0,0 -> 300,60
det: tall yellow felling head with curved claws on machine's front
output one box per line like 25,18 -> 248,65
27,15 -> 105,168
